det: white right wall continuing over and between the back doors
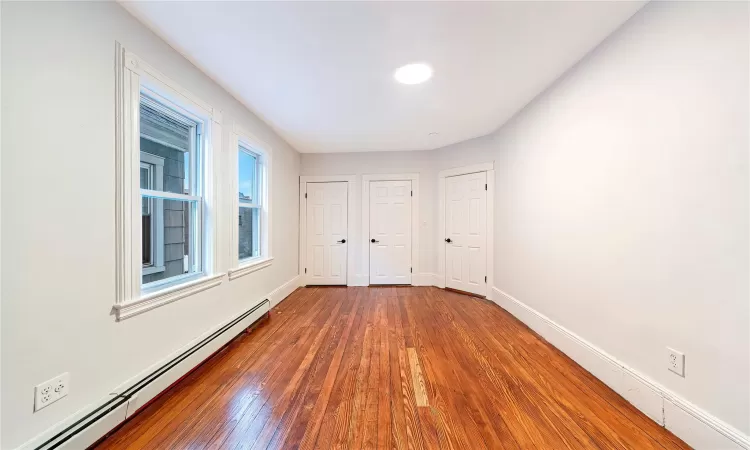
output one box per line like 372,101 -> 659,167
302,2 -> 750,435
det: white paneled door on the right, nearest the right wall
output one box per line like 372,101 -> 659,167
445,172 -> 487,296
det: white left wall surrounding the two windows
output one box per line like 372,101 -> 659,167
0,2 -> 299,449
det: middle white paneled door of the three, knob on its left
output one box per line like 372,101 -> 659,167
370,181 -> 412,284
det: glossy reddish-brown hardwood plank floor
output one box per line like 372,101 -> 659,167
96,287 -> 689,449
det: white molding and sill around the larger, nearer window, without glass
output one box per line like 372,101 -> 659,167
114,43 -> 223,320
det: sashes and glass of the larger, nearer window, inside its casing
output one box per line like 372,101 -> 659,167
139,93 -> 205,292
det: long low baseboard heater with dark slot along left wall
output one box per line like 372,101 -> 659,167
33,299 -> 271,450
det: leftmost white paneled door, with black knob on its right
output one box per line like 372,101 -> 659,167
306,182 -> 349,285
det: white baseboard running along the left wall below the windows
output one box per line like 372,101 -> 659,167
17,275 -> 302,450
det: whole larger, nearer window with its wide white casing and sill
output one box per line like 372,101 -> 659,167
115,46 -> 221,319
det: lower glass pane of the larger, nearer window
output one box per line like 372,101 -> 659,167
141,198 -> 198,288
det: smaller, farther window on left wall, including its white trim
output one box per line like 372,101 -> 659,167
229,126 -> 272,279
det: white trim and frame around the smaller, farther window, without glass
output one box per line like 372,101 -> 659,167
229,123 -> 274,280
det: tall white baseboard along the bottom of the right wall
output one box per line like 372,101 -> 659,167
490,287 -> 750,450
